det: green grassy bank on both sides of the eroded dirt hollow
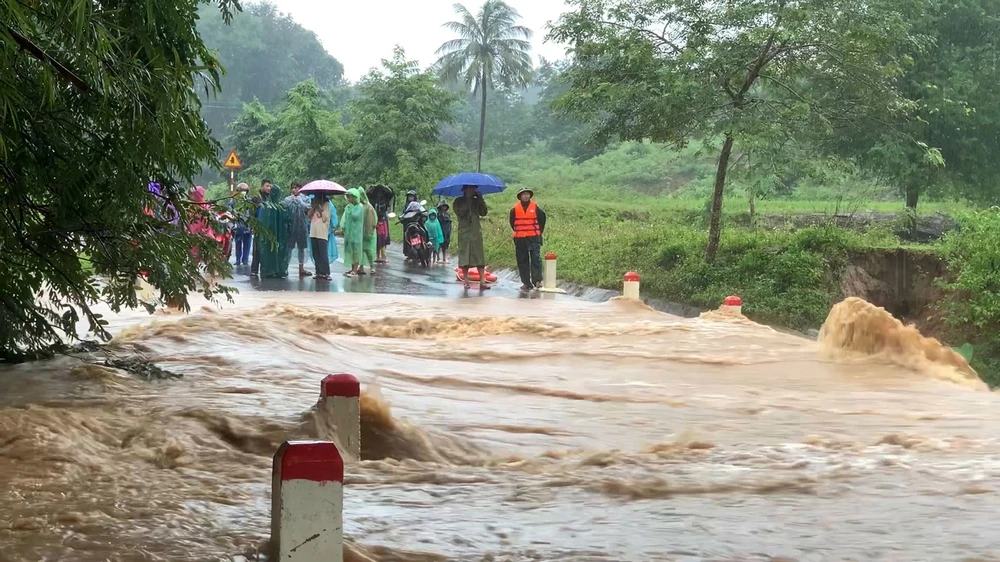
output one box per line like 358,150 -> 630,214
474,197 -> 1000,386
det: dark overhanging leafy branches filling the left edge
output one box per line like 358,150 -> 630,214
0,0 -> 236,360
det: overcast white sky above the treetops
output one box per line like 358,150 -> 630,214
272,0 -> 566,82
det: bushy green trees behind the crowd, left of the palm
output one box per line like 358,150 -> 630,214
229,48 -> 456,201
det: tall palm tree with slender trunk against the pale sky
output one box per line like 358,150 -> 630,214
437,0 -> 532,171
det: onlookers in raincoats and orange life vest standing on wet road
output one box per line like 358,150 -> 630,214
220,179 -> 546,291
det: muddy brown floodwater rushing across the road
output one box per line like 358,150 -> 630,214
0,293 -> 1000,562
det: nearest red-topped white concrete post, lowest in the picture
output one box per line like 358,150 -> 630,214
271,441 -> 344,562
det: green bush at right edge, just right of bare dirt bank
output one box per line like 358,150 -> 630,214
941,208 -> 1000,386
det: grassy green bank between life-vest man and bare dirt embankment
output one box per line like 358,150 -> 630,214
484,194 -> 898,329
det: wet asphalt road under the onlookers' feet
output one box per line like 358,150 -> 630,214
226,239 -> 570,298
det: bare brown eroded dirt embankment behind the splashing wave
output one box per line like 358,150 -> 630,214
840,248 -> 947,339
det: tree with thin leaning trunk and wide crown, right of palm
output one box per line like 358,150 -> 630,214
552,0 -> 914,260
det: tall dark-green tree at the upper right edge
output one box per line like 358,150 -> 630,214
838,0 -> 1000,208
